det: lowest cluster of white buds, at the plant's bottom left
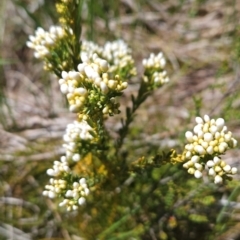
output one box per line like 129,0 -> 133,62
43,178 -> 90,211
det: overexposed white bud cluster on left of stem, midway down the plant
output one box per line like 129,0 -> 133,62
63,120 -> 94,163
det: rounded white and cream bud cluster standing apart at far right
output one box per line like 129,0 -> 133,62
183,115 -> 237,184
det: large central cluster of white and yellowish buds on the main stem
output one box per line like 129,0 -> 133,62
59,53 -> 128,114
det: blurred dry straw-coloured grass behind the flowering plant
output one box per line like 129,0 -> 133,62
0,0 -> 240,240
